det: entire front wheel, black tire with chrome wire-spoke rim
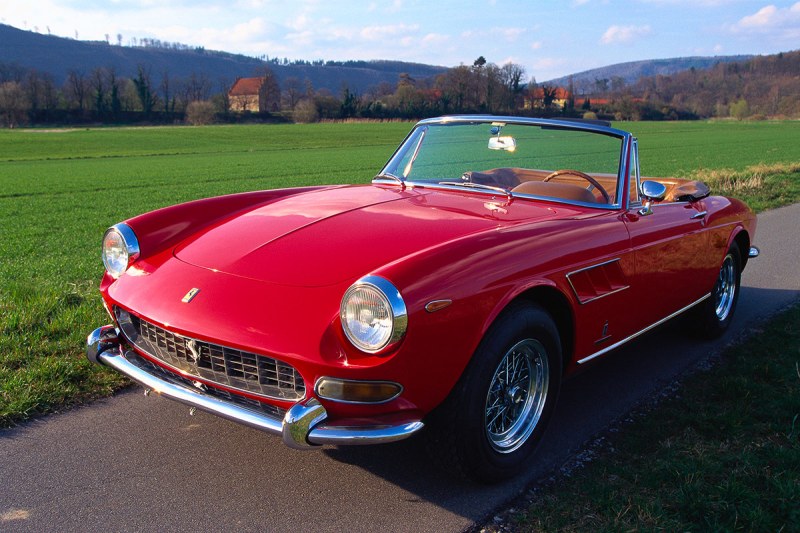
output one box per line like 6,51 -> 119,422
429,302 -> 562,483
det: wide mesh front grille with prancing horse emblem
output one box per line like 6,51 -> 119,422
114,307 -> 306,401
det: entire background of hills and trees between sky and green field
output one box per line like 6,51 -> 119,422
0,20 -> 800,127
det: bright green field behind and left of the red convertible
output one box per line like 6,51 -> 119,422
0,122 -> 800,425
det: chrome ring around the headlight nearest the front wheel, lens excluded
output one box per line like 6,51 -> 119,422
339,275 -> 408,354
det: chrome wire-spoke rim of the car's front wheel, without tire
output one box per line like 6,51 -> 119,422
484,339 -> 550,453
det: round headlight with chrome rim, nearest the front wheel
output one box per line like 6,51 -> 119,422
339,276 -> 408,353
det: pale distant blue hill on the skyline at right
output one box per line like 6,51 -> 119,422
545,55 -> 753,94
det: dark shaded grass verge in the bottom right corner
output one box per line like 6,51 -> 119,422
500,306 -> 800,532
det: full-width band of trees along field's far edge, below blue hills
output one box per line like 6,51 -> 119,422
0,51 -> 800,127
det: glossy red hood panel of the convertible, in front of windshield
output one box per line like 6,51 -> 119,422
174,186 -> 575,287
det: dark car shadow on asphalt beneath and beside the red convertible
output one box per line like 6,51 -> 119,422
316,287 -> 800,522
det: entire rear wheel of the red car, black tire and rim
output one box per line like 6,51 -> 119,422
690,242 -> 742,339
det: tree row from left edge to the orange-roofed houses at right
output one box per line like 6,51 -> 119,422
0,55 -> 544,127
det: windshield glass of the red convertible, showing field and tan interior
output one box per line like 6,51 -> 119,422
382,121 -> 623,205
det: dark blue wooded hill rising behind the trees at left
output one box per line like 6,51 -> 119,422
0,24 -> 446,94
